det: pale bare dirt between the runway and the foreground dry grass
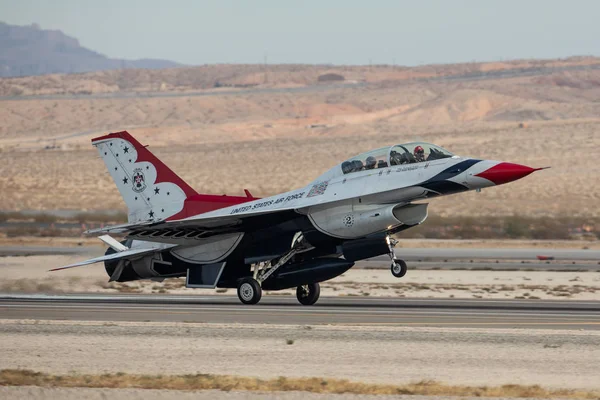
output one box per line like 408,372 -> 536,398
0,320 -> 600,389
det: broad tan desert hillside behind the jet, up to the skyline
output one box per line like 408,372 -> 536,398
0,58 -> 600,216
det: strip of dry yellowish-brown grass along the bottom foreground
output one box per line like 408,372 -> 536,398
0,369 -> 600,400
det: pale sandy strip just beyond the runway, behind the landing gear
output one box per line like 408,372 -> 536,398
0,253 -> 600,300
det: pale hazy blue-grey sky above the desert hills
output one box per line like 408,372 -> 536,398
0,0 -> 600,65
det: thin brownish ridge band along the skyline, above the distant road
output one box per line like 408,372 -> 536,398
0,57 -> 600,97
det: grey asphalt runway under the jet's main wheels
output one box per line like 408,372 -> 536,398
0,295 -> 600,330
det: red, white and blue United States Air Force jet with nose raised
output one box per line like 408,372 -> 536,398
54,131 -> 542,305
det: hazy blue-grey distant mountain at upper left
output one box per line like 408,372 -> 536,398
0,22 -> 181,77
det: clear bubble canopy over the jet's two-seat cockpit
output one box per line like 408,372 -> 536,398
341,142 -> 453,174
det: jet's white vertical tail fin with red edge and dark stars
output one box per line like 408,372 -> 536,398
92,131 -> 198,223
